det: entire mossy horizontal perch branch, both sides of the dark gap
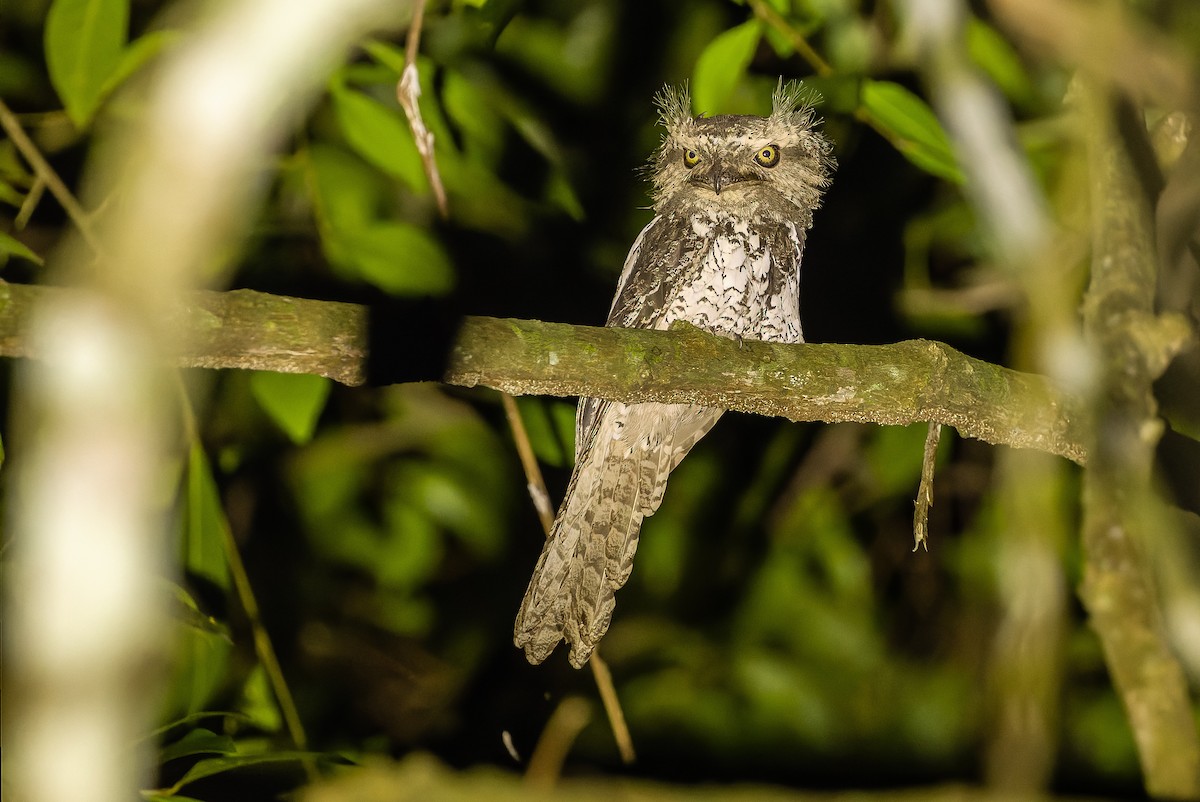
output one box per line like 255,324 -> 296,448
0,285 -> 1086,462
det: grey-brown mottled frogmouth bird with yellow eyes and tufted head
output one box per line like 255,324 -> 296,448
512,79 -> 835,669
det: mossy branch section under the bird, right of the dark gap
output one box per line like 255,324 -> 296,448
445,318 -> 1086,462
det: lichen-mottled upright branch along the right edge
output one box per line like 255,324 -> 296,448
1076,80 -> 1200,798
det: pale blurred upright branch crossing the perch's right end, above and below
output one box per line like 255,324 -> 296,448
899,0 -> 1070,795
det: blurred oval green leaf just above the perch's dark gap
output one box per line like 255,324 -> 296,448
338,222 -> 454,295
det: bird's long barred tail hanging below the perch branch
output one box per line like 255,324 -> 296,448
512,402 -> 721,669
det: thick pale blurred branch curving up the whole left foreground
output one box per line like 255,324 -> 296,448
5,0 -> 394,802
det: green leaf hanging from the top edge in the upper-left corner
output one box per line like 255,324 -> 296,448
46,0 -> 130,128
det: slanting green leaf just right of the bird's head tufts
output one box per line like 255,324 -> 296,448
862,80 -> 964,184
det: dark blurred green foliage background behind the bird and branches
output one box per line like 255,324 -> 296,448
0,0 -> 1200,800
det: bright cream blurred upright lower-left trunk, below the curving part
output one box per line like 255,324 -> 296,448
5,280 -> 167,802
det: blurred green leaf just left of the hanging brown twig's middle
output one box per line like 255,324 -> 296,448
331,84 -> 428,191
